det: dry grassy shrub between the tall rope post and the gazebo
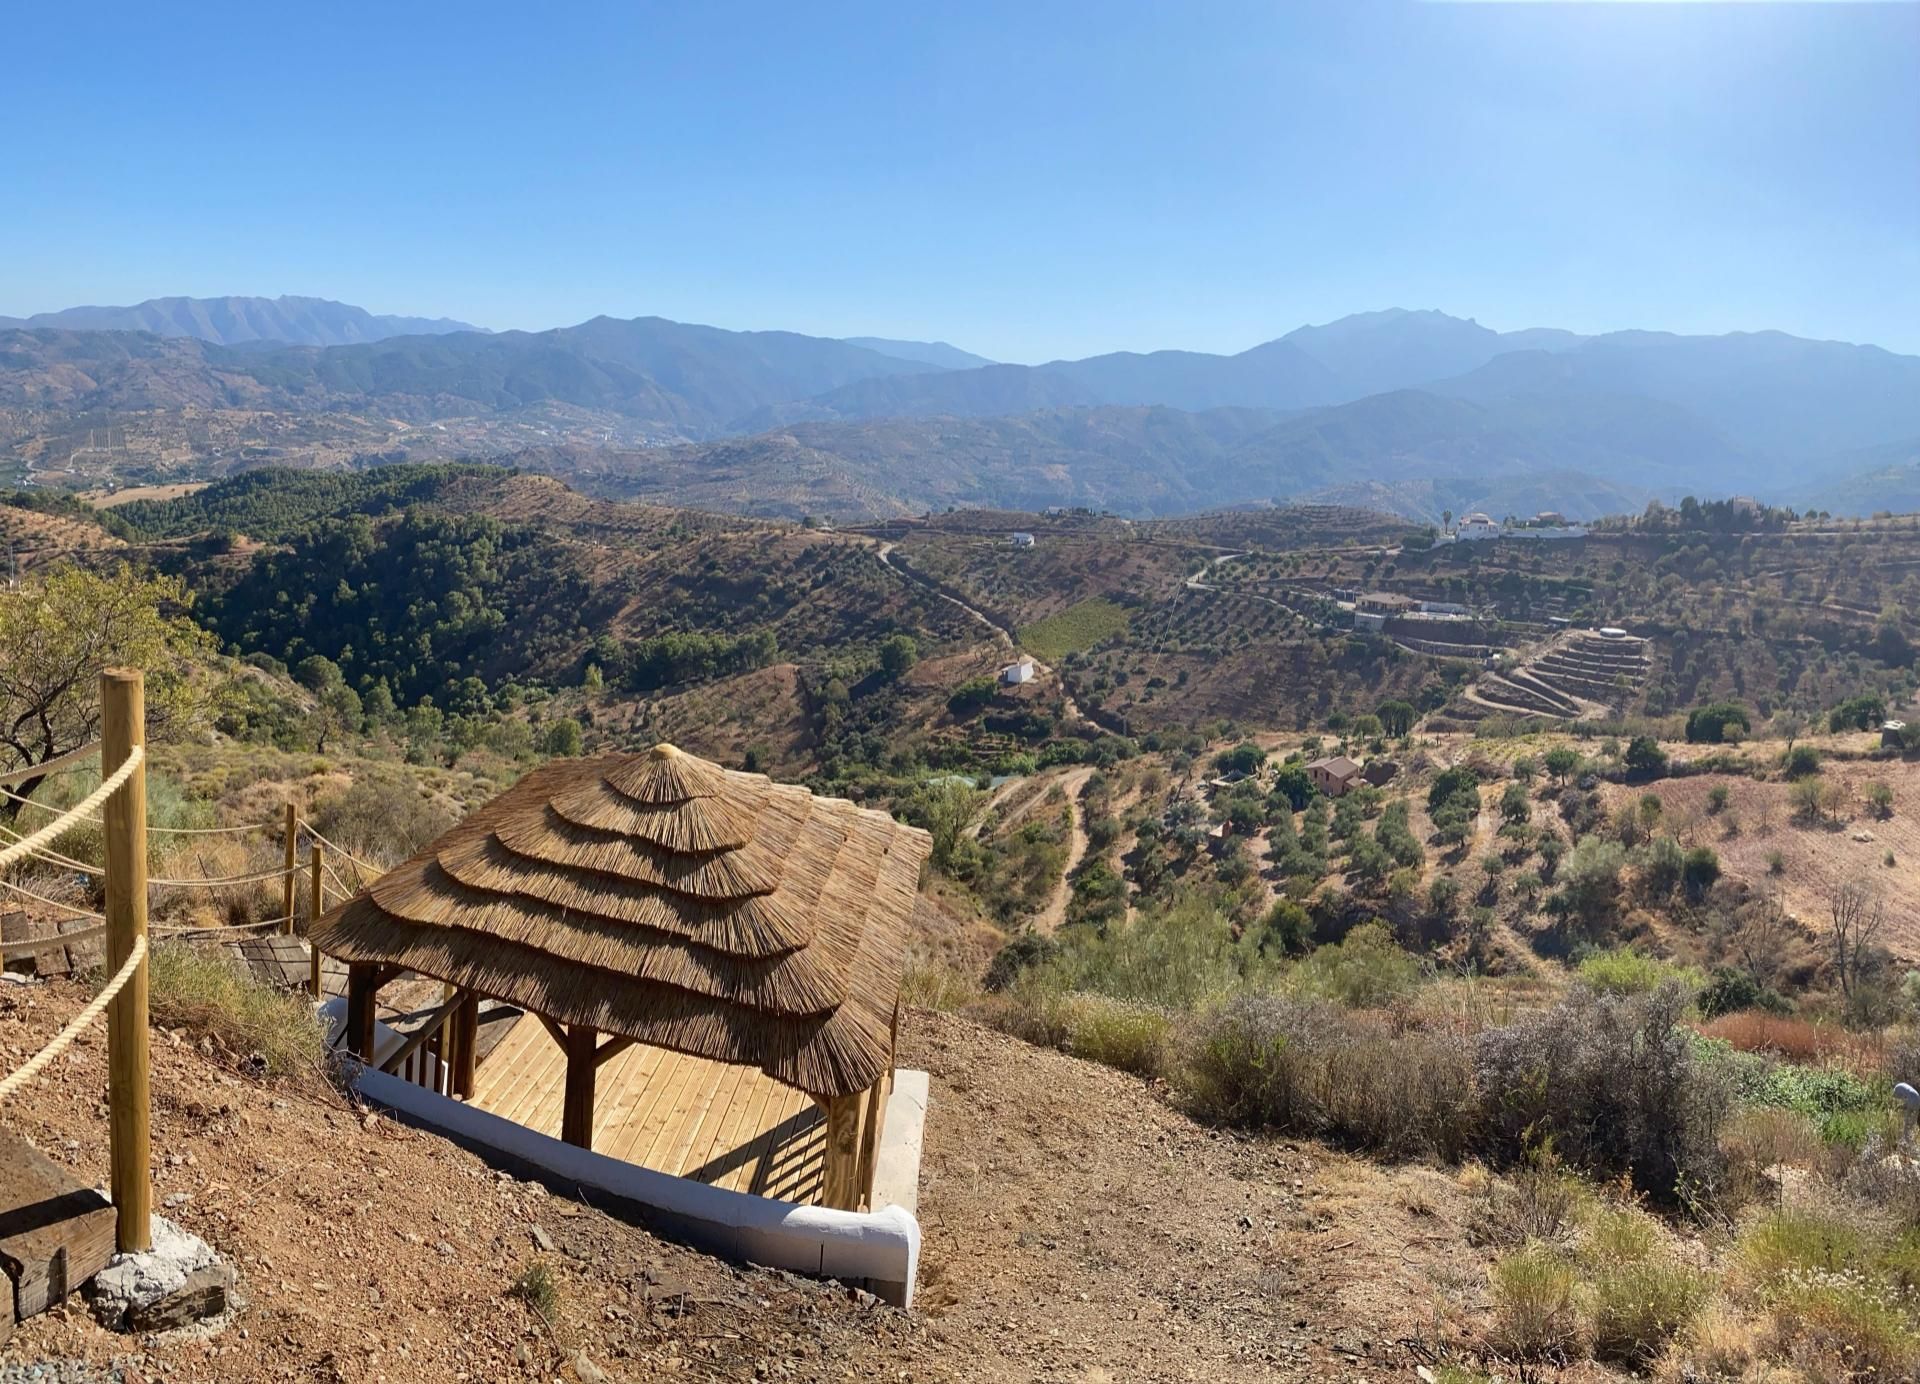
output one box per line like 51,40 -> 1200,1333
148,943 -> 326,1077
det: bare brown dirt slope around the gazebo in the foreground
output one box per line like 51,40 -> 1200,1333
0,983 -> 1566,1384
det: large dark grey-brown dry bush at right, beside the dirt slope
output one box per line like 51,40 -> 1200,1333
1475,983 -> 1732,1202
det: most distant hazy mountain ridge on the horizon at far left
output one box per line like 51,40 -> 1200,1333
0,296 -> 482,346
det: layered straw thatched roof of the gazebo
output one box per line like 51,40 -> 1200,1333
313,745 -> 931,1096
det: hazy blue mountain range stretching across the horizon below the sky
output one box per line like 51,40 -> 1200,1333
0,299 -> 1920,516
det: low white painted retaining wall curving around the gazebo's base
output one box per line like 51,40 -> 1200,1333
323,1000 -> 925,1307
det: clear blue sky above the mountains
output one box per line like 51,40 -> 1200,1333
0,0 -> 1920,361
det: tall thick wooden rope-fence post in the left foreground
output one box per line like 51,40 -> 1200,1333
100,668 -> 154,1253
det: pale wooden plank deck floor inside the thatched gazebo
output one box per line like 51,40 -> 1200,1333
472,1015 -> 826,1205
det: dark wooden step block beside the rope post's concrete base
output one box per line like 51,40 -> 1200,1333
0,1129 -> 117,1328
